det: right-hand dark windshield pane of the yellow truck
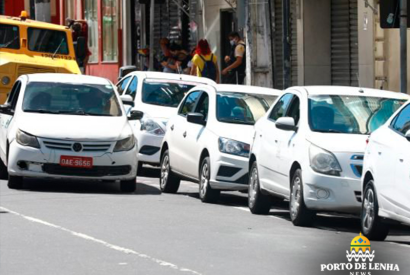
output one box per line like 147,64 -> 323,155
27,28 -> 68,54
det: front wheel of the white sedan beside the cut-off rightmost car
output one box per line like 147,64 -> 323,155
289,169 -> 315,226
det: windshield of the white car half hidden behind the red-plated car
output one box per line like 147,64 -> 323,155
142,79 -> 195,108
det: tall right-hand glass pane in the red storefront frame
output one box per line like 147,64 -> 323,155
102,0 -> 118,61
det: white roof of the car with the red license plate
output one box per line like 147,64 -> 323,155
27,73 -> 111,85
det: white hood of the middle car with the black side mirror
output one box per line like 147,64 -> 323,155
213,122 -> 254,145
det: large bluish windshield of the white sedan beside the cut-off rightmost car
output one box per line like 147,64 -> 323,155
309,95 -> 406,134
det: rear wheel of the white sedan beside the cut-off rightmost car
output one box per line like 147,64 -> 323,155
248,161 -> 272,214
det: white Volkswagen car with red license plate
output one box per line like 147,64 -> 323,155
0,74 -> 142,192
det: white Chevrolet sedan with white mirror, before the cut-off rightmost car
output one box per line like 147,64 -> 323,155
248,86 -> 409,226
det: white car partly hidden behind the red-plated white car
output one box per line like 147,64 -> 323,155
117,71 -> 215,169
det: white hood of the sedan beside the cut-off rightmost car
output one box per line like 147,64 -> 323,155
306,132 -> 369,153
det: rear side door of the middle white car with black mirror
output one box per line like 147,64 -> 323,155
167,90 -> 202,173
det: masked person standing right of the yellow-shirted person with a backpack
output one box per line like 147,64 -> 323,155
222,32 -> 246,85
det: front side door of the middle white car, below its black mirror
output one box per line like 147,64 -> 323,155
181,92 -> 209,178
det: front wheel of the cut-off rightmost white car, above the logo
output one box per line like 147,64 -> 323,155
360,180 -> 389,241
